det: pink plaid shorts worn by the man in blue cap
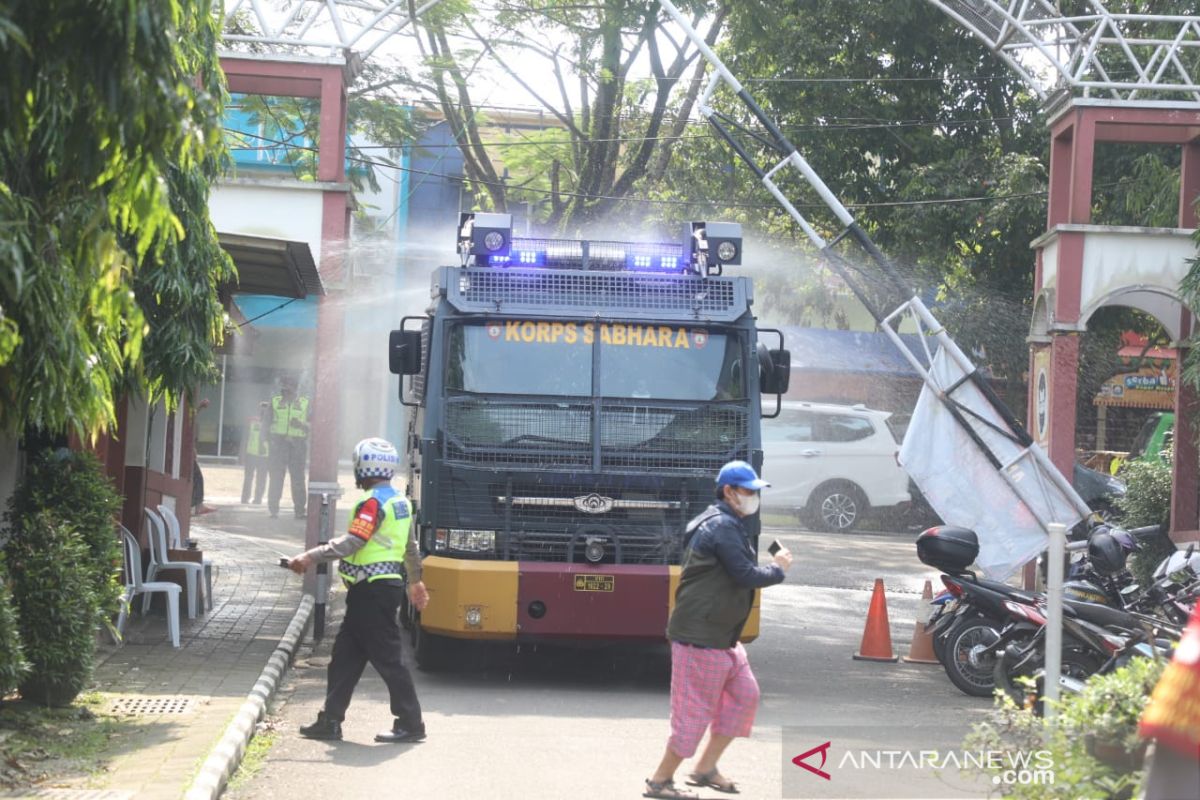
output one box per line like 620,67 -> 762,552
667,642 -> 758,758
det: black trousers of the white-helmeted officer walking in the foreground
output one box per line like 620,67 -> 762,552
325,581 -> 425,732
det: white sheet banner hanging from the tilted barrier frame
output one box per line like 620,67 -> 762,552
900,348 -> 1082,581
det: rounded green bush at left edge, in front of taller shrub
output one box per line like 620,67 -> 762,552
5,512 -> 98,706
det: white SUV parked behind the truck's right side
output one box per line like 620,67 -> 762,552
762,401 -> 912,531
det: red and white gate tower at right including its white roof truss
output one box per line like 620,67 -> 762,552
926,0 -> 1200,539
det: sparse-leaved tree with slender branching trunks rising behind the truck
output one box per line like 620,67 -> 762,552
410,0 -> 733,230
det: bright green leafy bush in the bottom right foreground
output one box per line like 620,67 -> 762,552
966,658 -> 1165,800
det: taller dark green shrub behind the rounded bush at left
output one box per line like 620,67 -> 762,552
8,449 -> 122,621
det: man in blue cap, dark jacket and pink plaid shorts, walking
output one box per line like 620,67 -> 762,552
642,461 -> 792,798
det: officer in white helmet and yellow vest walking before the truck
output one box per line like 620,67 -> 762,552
288,439 -> 430,742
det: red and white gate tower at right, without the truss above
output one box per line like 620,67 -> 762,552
1028,98 -> 1200,539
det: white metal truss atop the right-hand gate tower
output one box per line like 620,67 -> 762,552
926,0 -> 1200,106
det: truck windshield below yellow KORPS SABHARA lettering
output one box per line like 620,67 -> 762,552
446,320 -> 746,401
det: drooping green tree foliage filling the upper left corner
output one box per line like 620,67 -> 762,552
0,0 -> 233,434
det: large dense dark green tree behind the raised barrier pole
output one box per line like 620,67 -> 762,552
700,0 -> 1045,345
